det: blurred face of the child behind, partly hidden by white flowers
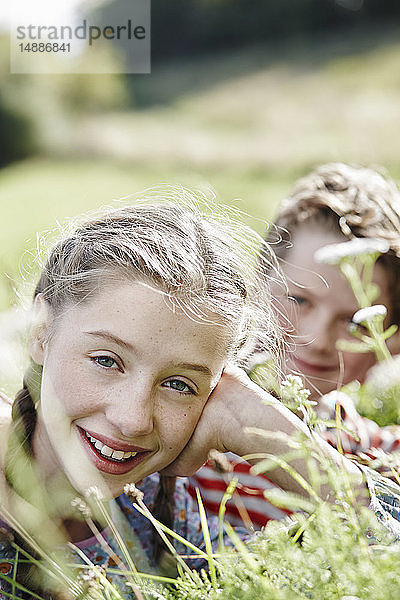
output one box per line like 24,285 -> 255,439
274,224 -> 391,400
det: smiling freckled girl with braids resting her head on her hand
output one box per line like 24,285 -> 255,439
0,203 -> 368,600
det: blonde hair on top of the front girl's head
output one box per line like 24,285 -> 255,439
35,202 -> 282,366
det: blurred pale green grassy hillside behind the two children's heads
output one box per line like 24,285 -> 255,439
0,26 -> 400,307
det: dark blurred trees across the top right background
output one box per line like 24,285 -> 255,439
100,0 -> 400,62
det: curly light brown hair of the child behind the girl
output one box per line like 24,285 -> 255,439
266,163 -> 400,325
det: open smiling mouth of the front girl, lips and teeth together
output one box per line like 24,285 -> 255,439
77,426 -> 151,475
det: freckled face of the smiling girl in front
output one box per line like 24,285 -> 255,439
32,282 -> 228,497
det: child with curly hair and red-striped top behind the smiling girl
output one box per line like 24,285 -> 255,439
190,163 -> 400,526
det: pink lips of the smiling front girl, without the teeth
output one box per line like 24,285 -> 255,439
77,426 -> 152,475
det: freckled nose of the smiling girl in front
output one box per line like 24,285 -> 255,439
106,385 -> 154,440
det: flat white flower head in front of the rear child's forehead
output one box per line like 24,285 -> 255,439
314,238 -> 390,265
